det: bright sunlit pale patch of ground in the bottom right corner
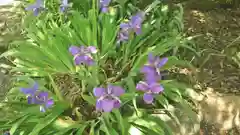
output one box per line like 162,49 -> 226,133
198,88 -> 240,135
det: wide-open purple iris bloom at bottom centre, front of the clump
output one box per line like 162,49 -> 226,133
93,84 -> 125,112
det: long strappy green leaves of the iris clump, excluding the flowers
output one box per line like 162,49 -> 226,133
0,0 -> 199,135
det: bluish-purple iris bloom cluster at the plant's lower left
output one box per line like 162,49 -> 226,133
20,82 -> 54,112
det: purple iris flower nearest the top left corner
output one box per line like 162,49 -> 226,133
25,0 -> 44,16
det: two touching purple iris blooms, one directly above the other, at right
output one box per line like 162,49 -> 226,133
136,53 -> 168,104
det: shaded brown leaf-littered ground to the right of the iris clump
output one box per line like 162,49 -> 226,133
185,3 -> 240,94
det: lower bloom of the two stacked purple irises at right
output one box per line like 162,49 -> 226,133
136,81 -> 164,104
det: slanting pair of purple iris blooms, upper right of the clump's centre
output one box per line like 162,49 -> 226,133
118,11 -> 144,43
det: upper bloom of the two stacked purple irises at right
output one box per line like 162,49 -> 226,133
141,53 -> 168,78
